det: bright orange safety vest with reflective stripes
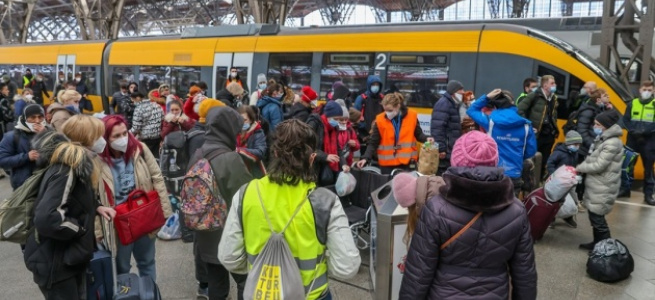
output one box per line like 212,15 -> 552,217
375,109 -> 418,167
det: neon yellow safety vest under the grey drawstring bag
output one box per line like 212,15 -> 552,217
239,177 -> 336,299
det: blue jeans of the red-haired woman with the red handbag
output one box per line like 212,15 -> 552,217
116,235 -> 157,281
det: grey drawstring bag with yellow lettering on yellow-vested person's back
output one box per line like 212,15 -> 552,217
241,183 -> 325,300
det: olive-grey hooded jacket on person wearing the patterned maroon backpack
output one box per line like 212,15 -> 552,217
190,107 -> 252,264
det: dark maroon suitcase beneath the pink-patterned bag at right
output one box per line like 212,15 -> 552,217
523,188 -> 562,241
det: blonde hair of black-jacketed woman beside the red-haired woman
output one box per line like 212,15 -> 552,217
61,115 -> 105,148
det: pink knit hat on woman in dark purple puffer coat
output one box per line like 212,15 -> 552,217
450,131 -> 498,167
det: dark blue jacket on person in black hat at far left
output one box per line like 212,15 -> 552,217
0,116 -> 40,190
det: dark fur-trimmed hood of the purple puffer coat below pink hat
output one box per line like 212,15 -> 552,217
439,167 -> 515,212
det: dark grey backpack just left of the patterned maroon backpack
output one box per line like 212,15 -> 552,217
159,130 -> 205,195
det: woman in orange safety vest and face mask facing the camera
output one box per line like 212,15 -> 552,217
357,93 -> 434,175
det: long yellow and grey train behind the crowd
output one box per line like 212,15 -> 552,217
0,23 -> 643,178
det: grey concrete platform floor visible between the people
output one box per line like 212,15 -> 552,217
0,175 -> 655,300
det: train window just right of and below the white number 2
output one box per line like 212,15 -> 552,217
385,65 -> 448,107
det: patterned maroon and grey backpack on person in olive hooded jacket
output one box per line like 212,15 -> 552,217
180,149 -> 228,231
